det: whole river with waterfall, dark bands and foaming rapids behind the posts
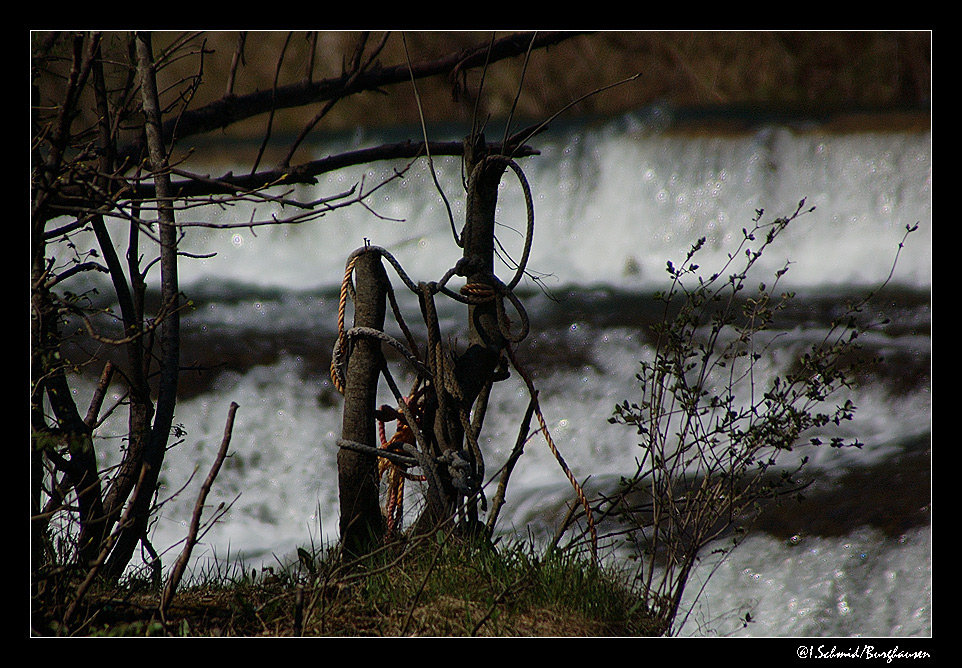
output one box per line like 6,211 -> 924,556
56,110 -> 932,637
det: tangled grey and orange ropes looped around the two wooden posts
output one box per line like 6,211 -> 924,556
331,155 -> 576,557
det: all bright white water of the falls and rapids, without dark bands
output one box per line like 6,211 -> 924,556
56,112 -> 932,636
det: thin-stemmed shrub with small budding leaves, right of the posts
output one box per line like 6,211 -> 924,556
602,200 -> 917,634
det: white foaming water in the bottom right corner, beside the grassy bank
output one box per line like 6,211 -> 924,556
680,528 -> 932,637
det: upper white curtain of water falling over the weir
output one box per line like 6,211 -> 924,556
172,123 -> 932,289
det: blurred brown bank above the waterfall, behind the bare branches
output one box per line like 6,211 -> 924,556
146,31 -> 932,134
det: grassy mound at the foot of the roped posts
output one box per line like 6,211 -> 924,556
34,538 -> 657,637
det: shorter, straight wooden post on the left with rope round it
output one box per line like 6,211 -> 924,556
337,251 -> 388,558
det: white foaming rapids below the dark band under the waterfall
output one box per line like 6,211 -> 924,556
84,340 -> 931,636
